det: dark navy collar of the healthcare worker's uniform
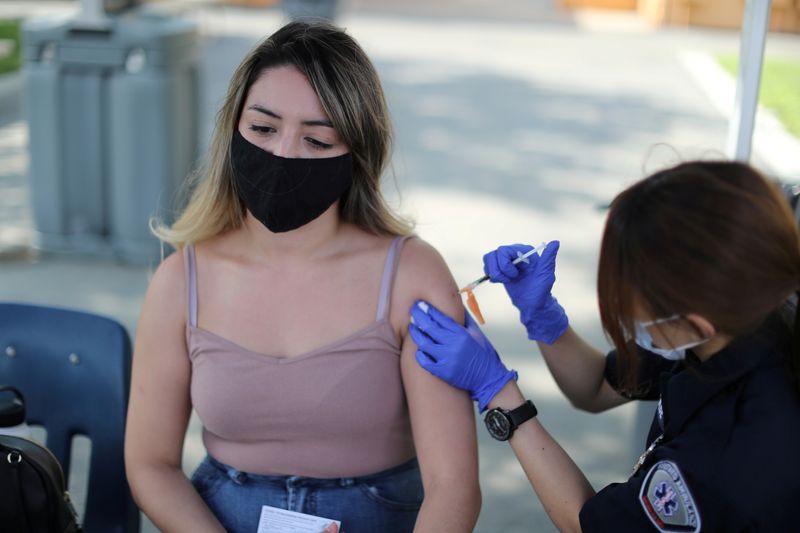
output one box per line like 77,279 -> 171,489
661,319 -> 779,436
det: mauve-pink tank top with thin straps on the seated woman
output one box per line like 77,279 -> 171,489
184,237 -> 415,478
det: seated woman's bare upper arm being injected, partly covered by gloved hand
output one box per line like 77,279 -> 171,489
392,239 -> 478,484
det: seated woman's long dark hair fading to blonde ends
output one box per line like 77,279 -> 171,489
151,22 -> 412,249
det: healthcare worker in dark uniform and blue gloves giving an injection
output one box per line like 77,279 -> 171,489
410,162 -> 800,532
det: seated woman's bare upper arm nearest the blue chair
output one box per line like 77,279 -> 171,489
125,249 -> 191,466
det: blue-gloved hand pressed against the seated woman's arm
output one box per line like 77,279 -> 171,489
408,300 -> 517,412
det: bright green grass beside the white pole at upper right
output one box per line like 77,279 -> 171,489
717,55 -> 800,137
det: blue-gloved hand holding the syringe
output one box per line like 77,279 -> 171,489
483,241 -> 569,344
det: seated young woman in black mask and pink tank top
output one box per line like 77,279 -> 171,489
125,22 -> 480,533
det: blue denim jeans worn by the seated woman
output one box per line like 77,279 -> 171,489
192,456 -> 423,533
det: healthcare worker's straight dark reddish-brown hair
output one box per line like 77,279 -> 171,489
597,161 -> 800,392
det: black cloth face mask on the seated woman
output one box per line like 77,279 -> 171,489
225,130 -> 353,233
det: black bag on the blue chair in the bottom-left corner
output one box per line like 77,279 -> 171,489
0,435 -> 81,533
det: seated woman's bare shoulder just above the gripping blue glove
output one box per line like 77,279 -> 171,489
392,237 -> 464,332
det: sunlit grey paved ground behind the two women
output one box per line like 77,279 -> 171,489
0,0 -> 800,533
